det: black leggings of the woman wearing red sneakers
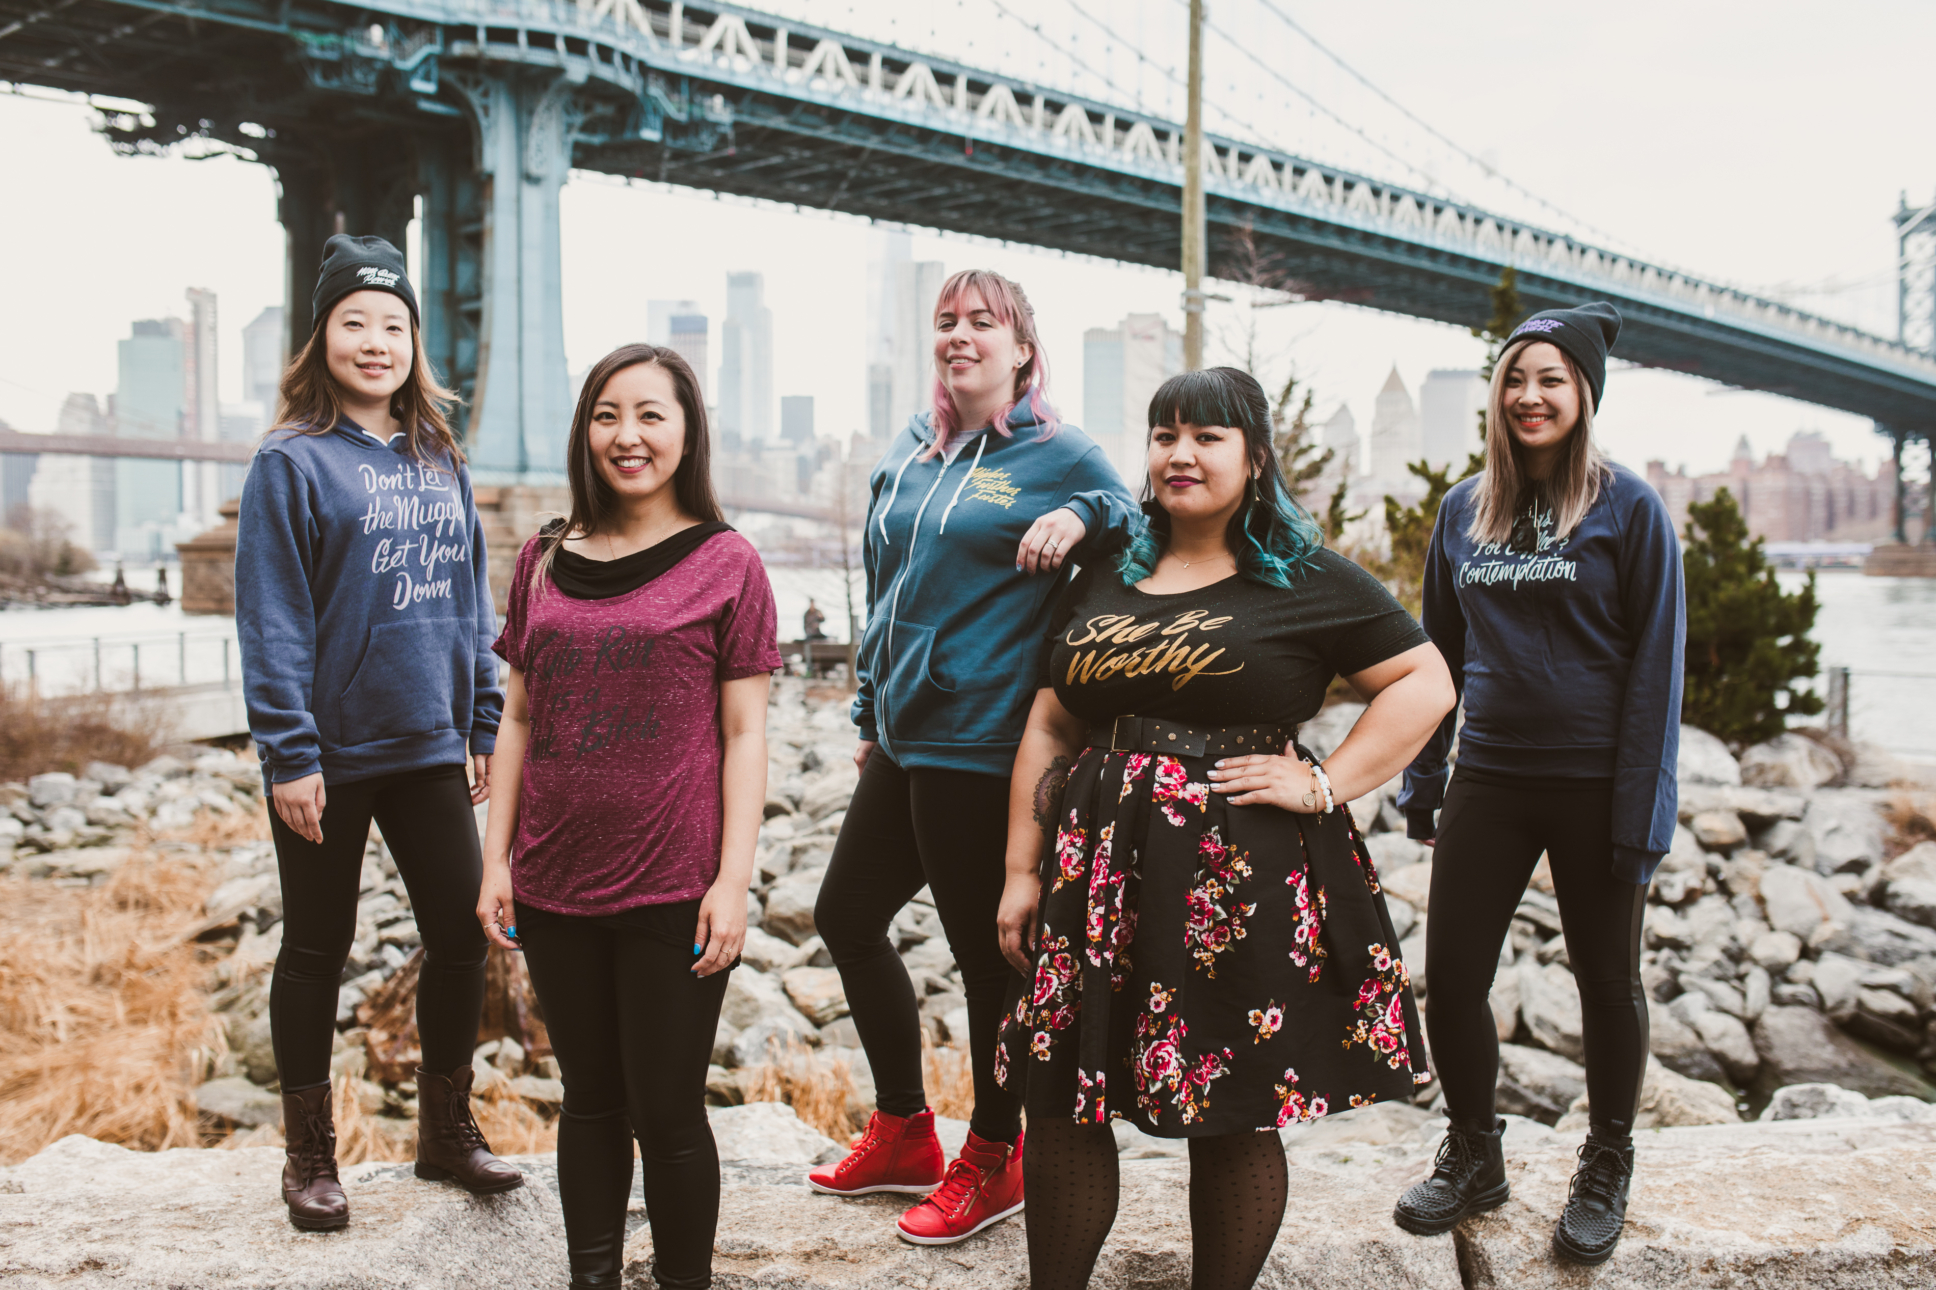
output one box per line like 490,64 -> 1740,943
813,748 -> 1022,1143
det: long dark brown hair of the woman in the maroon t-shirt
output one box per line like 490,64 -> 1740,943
536,345 -> 726,587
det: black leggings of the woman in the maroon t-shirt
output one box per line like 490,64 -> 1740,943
517,901 -> 730,1290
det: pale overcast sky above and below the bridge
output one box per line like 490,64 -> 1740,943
0,0 -> 1936,469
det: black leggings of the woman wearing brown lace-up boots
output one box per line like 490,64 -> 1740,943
269,765 -> 490,1092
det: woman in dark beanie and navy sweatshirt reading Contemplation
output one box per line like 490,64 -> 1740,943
1394,302 -> 1686,1263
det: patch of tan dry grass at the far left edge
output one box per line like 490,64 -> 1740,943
0,840 -> 225,1164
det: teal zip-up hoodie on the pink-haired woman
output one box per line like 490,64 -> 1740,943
854,407 -> 1142,775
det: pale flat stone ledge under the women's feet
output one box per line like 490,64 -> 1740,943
0,1116 -> 1936,1290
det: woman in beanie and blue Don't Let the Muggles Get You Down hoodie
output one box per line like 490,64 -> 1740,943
236,234 -> 525,1230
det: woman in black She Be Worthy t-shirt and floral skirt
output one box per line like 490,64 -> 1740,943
995,368 -> 1454,1290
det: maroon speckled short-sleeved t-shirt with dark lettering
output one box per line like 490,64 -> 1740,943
494,531 -> 780,916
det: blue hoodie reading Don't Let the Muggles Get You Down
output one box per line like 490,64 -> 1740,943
236,422 -> 503,784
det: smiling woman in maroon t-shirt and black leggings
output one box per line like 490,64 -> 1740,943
478,345 -> 780,1290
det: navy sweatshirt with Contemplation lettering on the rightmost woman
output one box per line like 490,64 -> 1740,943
1398,465 -> 1686,883
